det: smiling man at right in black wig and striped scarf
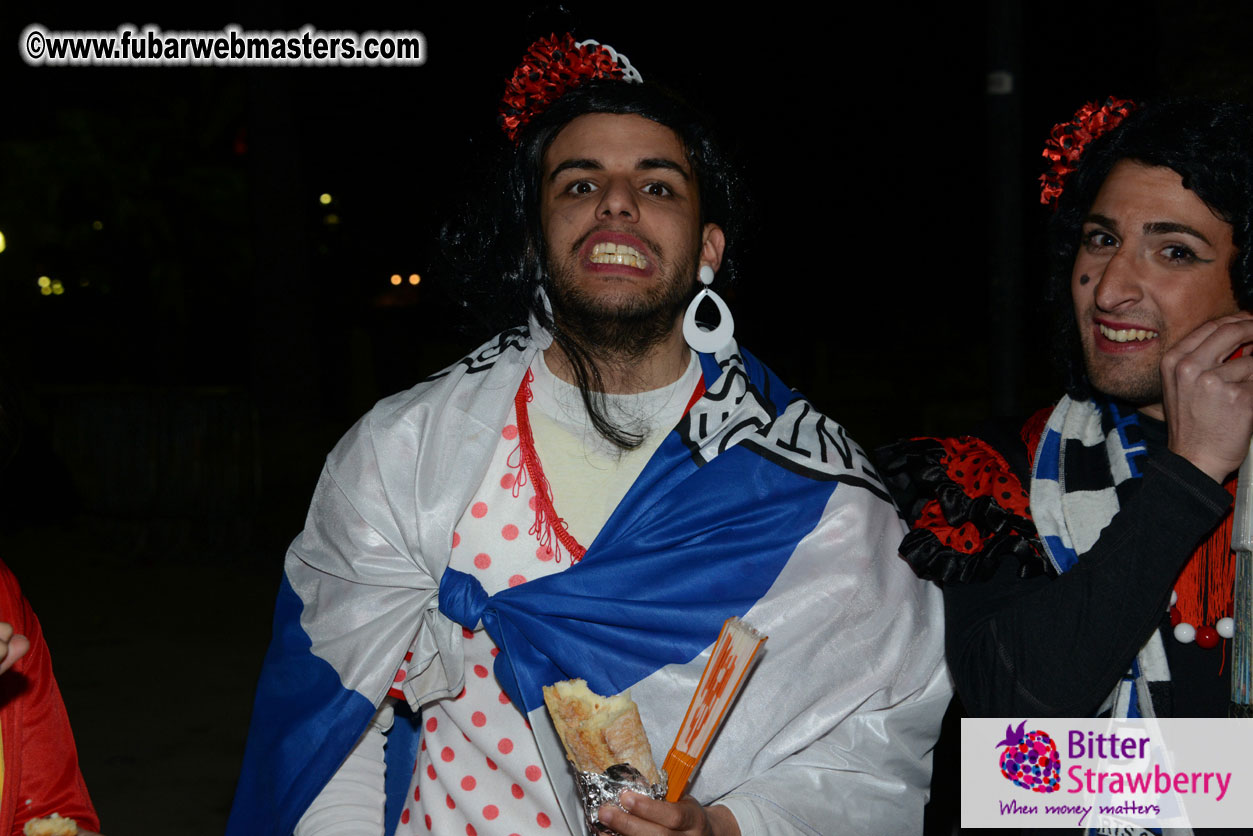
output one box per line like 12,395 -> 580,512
885,99 -> 1253,736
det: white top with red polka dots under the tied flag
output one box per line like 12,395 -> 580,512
393,355 -> 702,836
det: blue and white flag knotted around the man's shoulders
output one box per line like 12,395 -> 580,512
228,330 -> 950,835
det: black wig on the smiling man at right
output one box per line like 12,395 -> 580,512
1048,99 -> 1253,399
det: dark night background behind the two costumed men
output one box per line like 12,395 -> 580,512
0,0 -> 1253,836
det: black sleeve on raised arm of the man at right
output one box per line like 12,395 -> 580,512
944,450 -> 1232,717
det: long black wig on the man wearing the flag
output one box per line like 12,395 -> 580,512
440,80 -> 751,449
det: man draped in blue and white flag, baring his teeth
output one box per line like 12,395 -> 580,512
231,36 -> 950,836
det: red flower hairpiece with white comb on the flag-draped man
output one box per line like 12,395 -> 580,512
500,33 -> 644,143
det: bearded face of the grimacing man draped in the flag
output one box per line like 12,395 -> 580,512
541,113 -> 722,360
